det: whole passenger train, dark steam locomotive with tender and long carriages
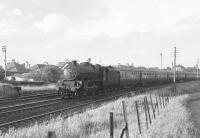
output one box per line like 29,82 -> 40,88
57,61 -> 196,98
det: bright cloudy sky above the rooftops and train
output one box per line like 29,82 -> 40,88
0,0 -> 200,67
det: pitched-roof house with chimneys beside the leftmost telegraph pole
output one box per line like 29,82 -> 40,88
6,60 -> 29,74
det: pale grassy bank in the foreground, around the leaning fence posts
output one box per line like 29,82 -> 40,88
2,82 -> 200,138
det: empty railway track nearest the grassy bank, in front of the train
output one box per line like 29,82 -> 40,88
0,85 -> 169,130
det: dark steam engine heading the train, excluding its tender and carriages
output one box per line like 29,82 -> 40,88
58,61 -> 103,98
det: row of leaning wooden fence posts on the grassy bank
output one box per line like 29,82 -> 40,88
47,86 -> 180,138
